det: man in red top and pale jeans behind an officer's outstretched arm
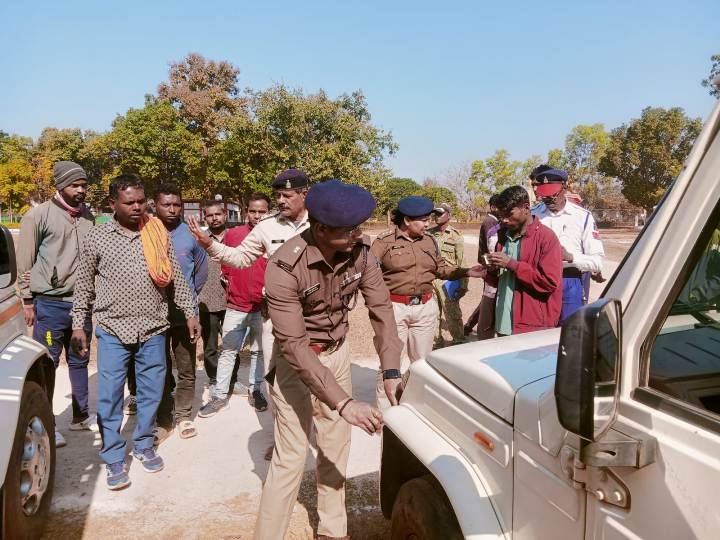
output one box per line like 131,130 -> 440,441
198,193 -> 270,418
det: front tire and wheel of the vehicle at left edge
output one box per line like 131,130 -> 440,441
2,381 -> 55,540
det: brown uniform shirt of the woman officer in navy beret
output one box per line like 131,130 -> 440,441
371,227 -> 468,296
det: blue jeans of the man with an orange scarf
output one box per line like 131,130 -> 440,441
95,326 -> 165,464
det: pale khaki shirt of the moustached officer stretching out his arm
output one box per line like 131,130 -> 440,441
207,210 -> 310,268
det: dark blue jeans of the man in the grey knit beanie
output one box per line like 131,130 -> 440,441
33,297 -> 92,422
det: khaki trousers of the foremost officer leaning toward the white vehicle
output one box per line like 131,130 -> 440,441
254,345 -> 352,540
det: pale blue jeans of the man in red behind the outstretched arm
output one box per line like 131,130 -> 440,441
215,308 -> 265,399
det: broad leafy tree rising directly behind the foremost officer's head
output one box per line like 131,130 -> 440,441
212,85 -> 397,202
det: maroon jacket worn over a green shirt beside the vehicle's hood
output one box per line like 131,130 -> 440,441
487,218 -> 562,334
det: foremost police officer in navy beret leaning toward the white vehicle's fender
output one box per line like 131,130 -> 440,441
255,180 -> 402,540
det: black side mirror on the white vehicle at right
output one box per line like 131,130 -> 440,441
555,299 -> 622,442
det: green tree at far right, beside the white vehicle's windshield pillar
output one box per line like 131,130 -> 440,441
598,107 -> 702,212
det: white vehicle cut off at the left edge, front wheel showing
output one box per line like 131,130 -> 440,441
0,226 -> 55,540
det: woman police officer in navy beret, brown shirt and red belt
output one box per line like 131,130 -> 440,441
371,196 -> 485,409
